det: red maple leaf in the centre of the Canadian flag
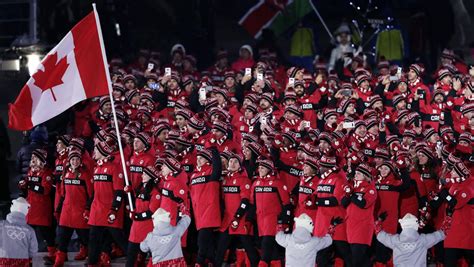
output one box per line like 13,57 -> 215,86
33,52 -> 69,101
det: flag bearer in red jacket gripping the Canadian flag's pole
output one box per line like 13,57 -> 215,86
124,166 -> 161,267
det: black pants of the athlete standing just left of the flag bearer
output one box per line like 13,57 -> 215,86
88,226 -> 127,264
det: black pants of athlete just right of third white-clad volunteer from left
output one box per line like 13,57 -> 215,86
316,240 -> 352,267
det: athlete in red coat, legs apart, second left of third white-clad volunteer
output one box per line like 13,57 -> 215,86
216,152 -> 259,266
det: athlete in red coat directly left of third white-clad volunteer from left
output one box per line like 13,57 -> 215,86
250,159 -> 291,266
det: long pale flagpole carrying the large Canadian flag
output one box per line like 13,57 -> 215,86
92,3 -> 134,211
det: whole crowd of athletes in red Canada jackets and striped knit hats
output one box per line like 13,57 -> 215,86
3,35 -> 474,267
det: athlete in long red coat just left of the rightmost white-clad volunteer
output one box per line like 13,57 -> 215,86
342,163 -> 377,267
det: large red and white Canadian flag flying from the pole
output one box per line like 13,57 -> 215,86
8,11 -> 110,130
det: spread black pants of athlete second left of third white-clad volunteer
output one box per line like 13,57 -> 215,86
216,230 -> 259,267
